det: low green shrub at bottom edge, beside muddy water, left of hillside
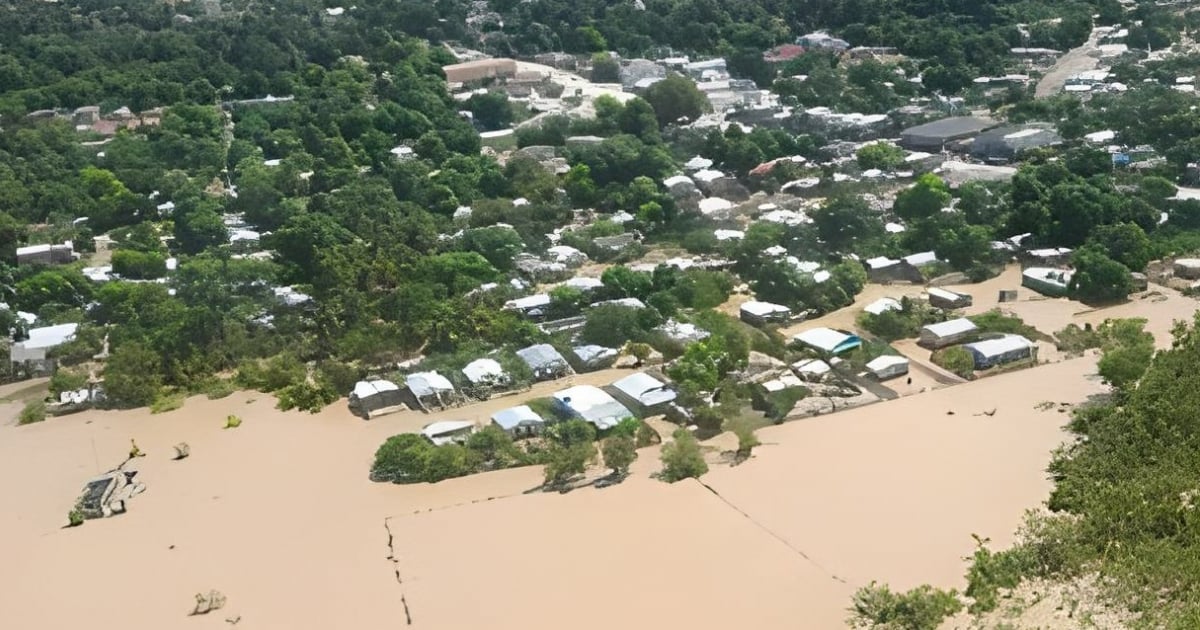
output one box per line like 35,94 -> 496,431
848,582 -> 962,630
